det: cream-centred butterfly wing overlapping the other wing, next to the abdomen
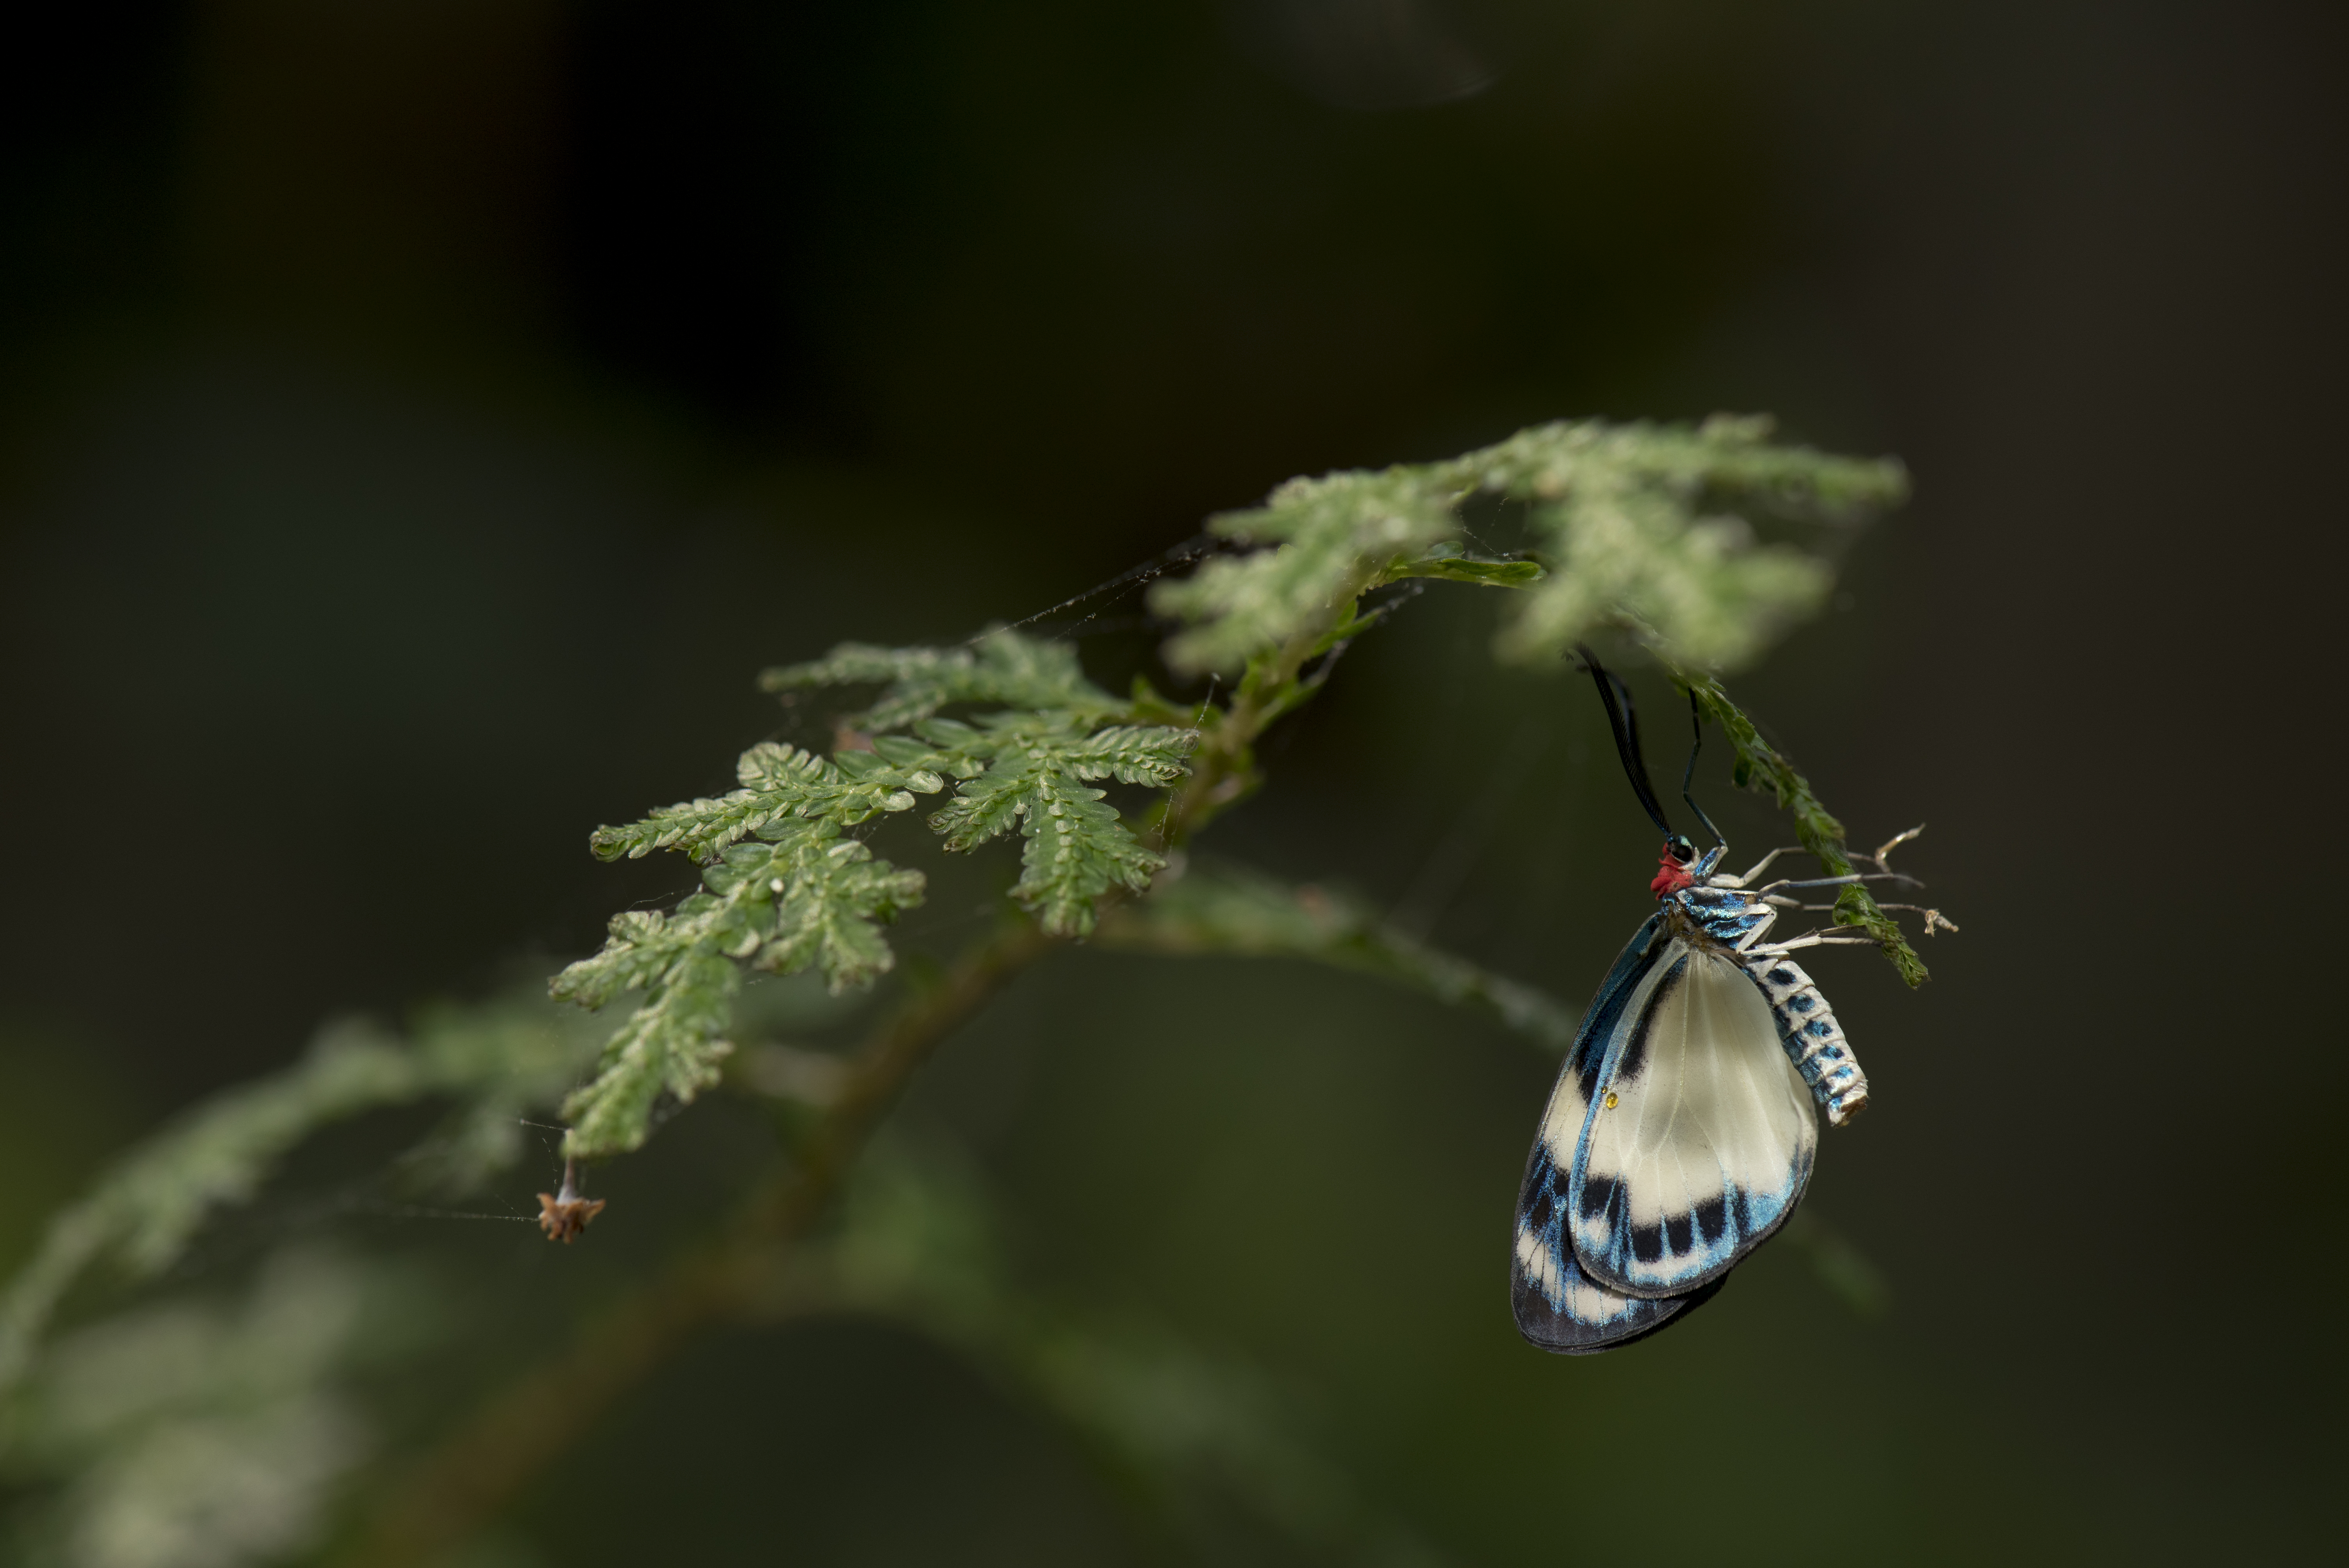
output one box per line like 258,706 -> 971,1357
1565,939 -> 1818,1298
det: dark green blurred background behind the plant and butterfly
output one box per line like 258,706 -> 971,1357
0,0 -> 2349,1563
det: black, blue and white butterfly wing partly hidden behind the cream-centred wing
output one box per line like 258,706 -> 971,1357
1510,916 -> 1717,1354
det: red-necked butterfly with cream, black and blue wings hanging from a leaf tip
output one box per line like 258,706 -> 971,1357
1510,648 -> 1938,1354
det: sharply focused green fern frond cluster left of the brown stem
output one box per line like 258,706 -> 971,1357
566,629 -> 1196,1155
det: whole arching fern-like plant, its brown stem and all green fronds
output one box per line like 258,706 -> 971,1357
0,408 -> 1900,1568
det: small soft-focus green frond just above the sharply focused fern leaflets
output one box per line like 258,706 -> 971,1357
759,629 -> 1125,735
